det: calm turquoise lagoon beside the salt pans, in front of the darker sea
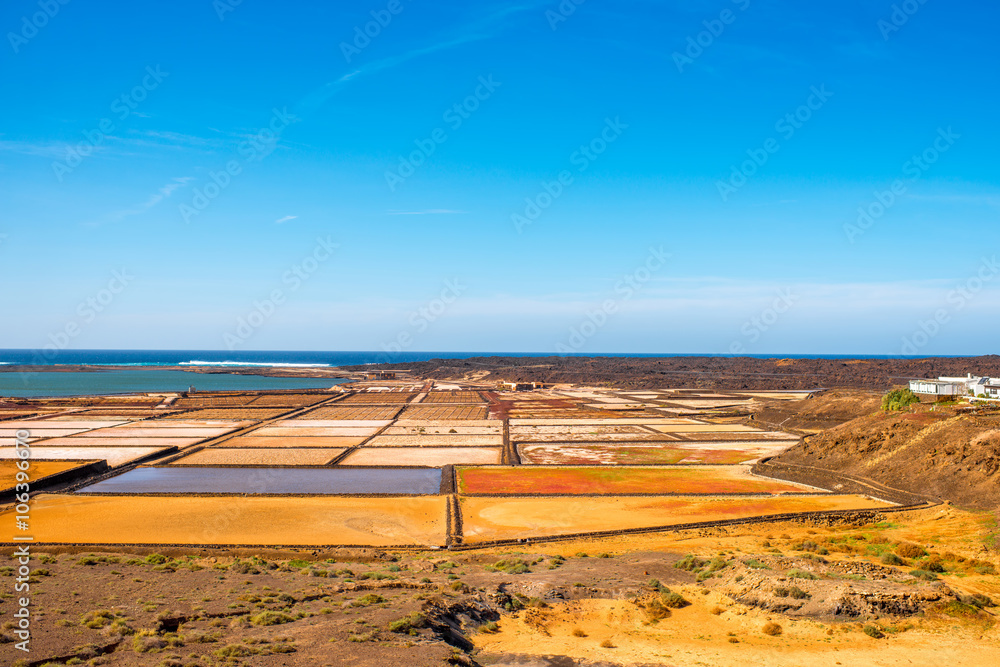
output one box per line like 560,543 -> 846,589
0,368 -> 345,398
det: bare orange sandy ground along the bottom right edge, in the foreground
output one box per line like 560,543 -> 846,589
475,587 -> 1000,667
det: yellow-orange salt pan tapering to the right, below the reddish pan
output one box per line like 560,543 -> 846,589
460,495 -> 890,543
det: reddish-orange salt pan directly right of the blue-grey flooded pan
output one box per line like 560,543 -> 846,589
456,466 -> 818,495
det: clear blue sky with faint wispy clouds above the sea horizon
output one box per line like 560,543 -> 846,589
0,0 -> 1000,354
